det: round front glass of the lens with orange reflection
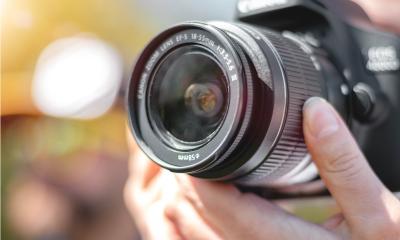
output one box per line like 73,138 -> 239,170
148,46 -> 228,145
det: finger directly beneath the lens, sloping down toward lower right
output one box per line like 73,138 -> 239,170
175,176 -> 336,240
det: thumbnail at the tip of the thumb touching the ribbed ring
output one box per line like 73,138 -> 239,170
303,97 -> 339,139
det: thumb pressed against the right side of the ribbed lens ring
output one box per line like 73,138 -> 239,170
304,98 -> 393,231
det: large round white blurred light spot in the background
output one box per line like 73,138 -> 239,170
32,35 -> 123,119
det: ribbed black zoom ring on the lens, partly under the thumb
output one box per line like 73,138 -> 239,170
239,31 -> 322,185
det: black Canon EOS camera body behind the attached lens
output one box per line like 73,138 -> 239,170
237,0 -> 400,191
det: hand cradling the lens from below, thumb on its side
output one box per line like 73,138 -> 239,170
125,98 -> 400,240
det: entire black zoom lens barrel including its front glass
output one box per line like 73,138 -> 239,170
127,22 -> 325,186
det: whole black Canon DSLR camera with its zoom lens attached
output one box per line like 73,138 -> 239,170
127,0 -> 400,191
